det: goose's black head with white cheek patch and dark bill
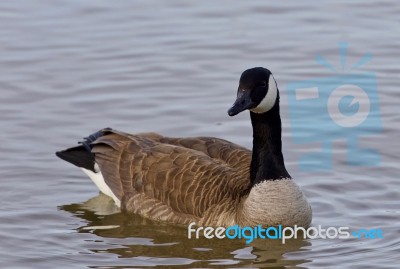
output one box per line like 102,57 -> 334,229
228,67 -> 278,116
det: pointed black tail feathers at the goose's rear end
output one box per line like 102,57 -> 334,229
56,128 -> 112,172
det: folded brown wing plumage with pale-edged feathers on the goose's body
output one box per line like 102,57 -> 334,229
93,131 -> 249,223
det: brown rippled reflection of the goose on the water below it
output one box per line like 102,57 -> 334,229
59,194 -> 311,268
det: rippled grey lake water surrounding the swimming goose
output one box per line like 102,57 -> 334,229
0,0 -> 400,269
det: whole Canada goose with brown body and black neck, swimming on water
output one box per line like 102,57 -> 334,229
56,67 -> 312,227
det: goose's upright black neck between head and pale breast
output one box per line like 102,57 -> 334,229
250,97 -> 290,186
